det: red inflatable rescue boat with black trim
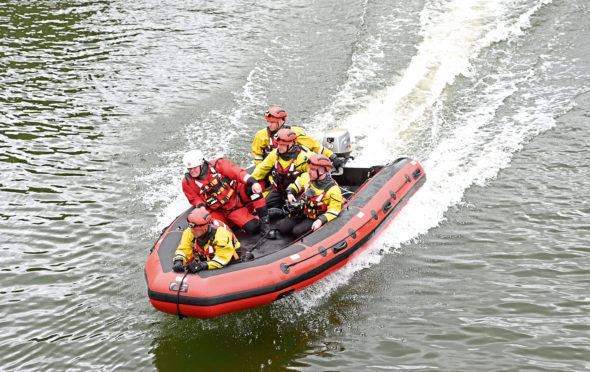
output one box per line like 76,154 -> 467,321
145,152 -> 426,318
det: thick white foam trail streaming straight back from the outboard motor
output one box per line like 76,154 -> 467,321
339,0 -> 548,165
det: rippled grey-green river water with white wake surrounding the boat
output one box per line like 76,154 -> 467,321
0,0 -> 590,371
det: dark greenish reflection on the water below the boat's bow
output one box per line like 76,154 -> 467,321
150,295 -> 358,371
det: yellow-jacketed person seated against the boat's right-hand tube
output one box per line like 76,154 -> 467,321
277,154 -> 342,237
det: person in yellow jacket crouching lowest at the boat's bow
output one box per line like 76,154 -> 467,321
172,208 -> 240,273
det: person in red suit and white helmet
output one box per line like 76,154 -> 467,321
182,150 -> 270,234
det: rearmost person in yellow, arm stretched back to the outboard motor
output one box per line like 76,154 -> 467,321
252,106 -> 344,168
